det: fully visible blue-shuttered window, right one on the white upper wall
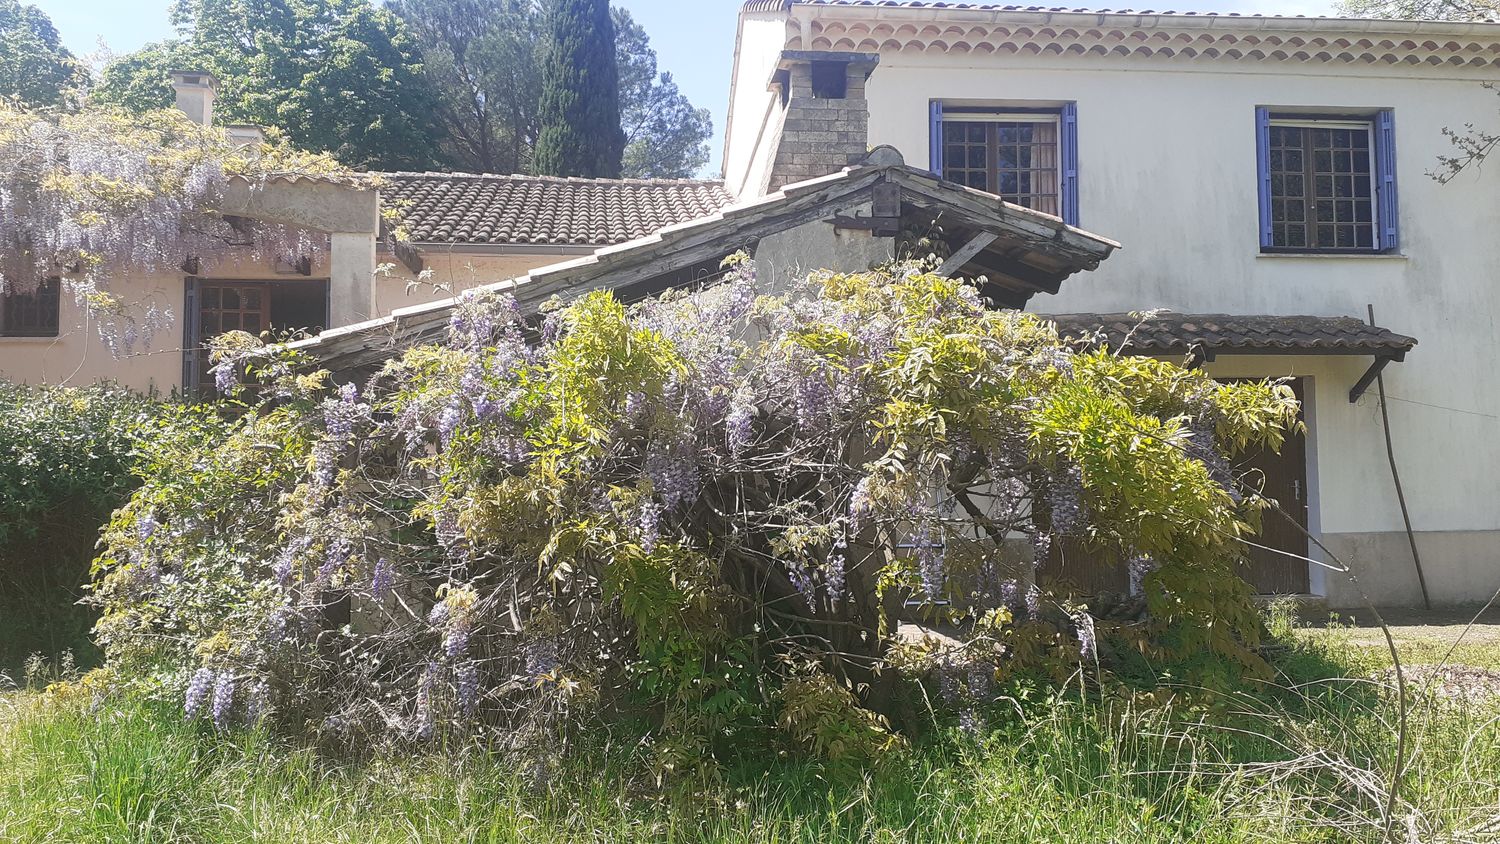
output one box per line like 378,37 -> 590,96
1256,108 -> 1400,253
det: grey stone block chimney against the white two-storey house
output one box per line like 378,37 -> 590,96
767,49 -> 881,192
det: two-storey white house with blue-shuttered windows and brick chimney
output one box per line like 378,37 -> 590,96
725,0 -> 1500,606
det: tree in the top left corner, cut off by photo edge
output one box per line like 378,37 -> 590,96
0,0 -> 87,106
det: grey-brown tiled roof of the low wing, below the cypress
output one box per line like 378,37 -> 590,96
380,172 -> 732,246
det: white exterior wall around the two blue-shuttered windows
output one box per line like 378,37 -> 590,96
867,51 -> 1500,606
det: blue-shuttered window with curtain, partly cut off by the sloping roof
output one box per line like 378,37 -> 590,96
929,100 -> 1079,225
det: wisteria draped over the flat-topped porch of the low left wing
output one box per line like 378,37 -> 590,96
0,103 -> 362,355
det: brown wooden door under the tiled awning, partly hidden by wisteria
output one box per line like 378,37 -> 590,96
1236,379 -> 1308,595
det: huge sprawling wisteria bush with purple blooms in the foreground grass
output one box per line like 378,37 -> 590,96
96,261 -> 1296,768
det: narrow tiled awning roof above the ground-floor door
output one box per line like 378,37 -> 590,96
1044,312 -> 1416,355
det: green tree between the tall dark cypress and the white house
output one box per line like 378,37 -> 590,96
615,6 -> 714,178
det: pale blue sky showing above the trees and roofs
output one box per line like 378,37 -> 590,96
30,0 -> 1334,172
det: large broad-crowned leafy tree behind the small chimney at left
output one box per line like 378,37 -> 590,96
93,0 -> 441,169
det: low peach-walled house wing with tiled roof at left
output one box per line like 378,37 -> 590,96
0,72 -> 732,393
